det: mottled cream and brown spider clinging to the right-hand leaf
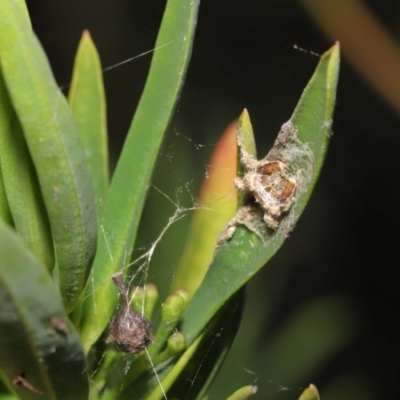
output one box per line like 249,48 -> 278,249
217,121 -> 304,248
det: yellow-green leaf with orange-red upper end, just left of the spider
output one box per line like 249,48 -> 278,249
172,121 -> 237,296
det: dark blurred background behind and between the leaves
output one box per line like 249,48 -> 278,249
27,0 -> 400,400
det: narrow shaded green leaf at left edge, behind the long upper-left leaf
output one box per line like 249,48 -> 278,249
0,73 -> 55,271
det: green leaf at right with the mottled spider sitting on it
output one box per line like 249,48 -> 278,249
181,44 -> 339,343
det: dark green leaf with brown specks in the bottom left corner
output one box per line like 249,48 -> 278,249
0,221 -> 89,400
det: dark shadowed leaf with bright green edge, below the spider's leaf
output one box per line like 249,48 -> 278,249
121,288 -> 246,400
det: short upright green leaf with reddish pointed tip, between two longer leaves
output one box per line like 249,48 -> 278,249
68,31 -> 109,206
